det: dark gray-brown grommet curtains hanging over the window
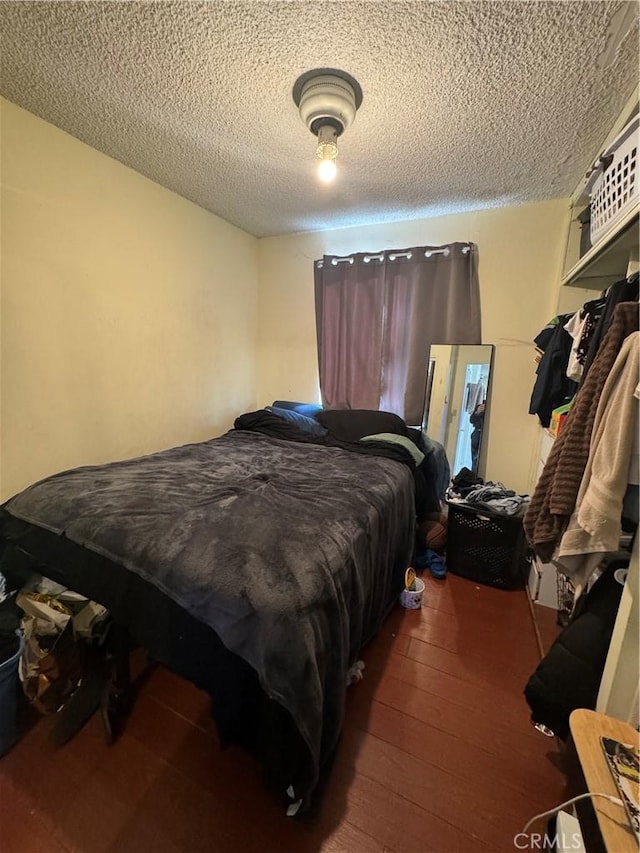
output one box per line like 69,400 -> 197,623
314,243 -> 482,424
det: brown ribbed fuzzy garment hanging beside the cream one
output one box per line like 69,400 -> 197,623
524,302 -> 638,562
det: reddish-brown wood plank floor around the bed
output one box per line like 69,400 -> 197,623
0,575 -> 566,853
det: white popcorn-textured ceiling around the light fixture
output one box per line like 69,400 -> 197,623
0,0 -> 638,235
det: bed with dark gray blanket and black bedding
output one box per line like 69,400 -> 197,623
0,410 -> 425,807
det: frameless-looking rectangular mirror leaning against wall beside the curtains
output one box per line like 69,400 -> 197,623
423,344 -> 493,476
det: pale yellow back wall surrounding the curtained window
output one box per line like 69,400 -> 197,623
258,200 -> 568,491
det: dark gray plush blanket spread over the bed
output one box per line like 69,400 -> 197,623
6,430 -> 415,788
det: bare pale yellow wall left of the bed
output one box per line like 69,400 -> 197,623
0,100 -> 258,498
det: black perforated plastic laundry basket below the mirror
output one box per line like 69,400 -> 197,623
447,503 -> 528,589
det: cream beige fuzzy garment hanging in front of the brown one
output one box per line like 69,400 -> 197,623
553,332 -> 640,595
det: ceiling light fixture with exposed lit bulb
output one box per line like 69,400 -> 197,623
293,68 -> 362,183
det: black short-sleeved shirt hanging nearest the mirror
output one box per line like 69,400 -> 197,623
529,314 -> 578,427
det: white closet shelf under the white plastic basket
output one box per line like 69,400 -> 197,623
562,205 -> 640,290
